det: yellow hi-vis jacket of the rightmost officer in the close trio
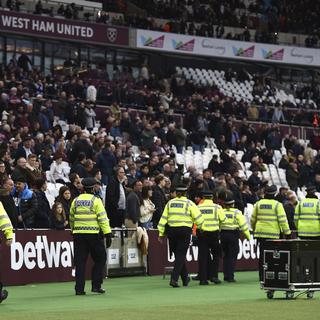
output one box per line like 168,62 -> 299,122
221,208 -> 250,240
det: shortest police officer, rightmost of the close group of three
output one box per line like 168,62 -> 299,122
220,191 -> 250,282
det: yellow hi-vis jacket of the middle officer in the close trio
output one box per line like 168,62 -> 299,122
198,199 -> 226,232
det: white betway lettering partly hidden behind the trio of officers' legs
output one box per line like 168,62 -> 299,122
167,236 -> 260,262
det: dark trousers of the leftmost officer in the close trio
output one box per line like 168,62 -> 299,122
168,227 -> 191,281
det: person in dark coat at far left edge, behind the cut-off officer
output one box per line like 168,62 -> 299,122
0,178 -> 18,228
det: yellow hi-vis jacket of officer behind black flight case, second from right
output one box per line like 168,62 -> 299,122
251,199 -> 291,239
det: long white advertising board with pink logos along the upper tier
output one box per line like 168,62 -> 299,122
136,30 -> 320,66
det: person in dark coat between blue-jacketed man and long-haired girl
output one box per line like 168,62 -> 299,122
34,178 -> 52,229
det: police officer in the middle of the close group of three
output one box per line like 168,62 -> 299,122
197,190 -> 226,285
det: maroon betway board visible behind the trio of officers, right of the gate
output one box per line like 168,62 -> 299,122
148,230 -> 259,275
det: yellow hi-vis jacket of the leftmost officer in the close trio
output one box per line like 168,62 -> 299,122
158,197 -> 203,237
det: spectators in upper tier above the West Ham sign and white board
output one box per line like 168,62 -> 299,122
0,0 -> 320,48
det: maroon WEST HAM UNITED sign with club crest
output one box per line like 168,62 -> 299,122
0,10 -> 129,46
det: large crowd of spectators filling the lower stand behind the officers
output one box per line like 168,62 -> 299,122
0,54 -> 320,229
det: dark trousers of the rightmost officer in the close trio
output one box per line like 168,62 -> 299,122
220,230 -> 239,280
